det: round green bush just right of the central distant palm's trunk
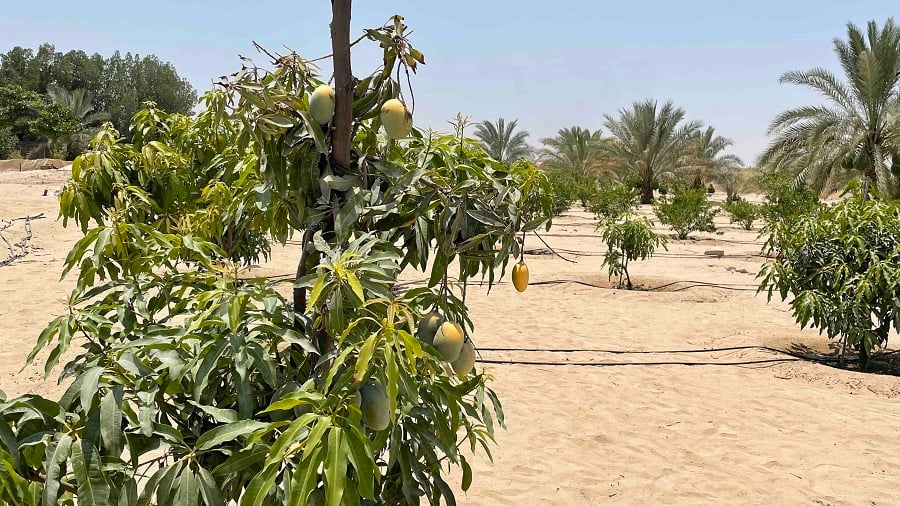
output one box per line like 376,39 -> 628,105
653,183 -> 719,240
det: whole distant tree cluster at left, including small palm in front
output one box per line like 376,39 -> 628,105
0,44 -> 197,158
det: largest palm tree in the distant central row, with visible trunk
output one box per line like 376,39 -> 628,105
604,99 -> 701,204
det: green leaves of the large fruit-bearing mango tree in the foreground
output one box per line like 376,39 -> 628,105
0,11 -> 551,506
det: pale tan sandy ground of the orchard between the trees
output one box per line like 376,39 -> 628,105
0,171 -> 900,506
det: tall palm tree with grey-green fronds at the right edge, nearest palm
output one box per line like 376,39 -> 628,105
759,18 -> 900,198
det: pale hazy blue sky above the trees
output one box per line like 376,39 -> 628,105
0,0 -> 897,164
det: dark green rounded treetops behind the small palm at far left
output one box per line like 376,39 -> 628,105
0,44 -> 197,133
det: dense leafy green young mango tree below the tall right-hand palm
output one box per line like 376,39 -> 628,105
760,196 -> 900,369
